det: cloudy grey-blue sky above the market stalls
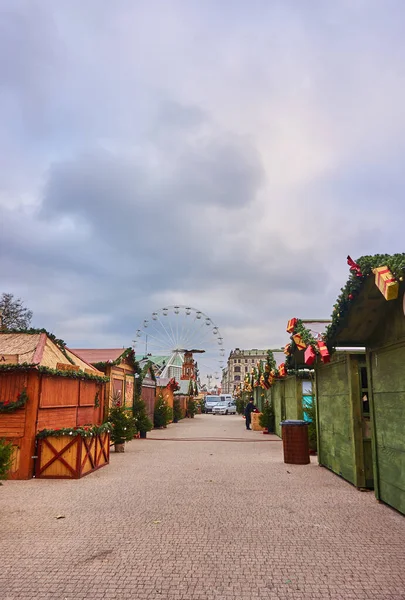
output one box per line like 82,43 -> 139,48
0,0 -> 405,376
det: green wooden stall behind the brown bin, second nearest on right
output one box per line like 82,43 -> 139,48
286,319 -> 373,488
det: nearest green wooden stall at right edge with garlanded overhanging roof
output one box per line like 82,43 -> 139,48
326,254 -> 405,514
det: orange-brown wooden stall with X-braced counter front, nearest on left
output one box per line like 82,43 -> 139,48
0,330 -> 109,479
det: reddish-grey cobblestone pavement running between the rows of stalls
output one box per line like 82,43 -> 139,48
0,415 -> 405,600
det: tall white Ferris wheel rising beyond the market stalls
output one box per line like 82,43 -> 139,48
133,305 -> 225,385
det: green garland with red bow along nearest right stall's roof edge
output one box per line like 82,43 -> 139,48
324,253 -> 405,346
